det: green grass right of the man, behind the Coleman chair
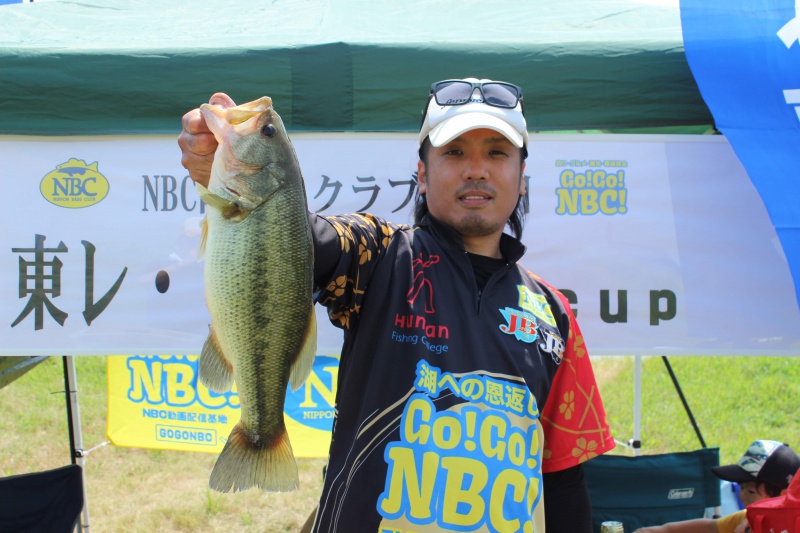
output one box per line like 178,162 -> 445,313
595,357 -> 800,463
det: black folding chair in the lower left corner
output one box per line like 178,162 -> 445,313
0,465 -> 83,533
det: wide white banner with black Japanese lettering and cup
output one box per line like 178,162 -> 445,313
0,134 -> 800,355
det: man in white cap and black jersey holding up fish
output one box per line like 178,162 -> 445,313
178,78 -> 614,533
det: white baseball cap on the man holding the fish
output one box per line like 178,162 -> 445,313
419,78 -> 528,148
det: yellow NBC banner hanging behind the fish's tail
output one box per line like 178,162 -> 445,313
107,355 -> 339,458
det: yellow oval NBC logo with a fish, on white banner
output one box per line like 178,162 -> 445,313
39,157 -> 108,209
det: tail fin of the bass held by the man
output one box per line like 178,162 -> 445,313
208,422 -> 300,492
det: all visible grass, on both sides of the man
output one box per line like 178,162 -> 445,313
0,357 -> 800,533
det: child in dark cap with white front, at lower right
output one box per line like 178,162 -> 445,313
634,440 -> 800,533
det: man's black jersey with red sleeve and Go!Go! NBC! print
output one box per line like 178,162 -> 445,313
311,215 -> 614,533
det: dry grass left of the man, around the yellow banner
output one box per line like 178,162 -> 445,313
0,357 -> 325,533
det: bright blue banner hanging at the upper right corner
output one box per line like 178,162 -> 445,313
681,0 -> 800,310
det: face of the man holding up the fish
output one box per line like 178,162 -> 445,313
418,129 -> 525,251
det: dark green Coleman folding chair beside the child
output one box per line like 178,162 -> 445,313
583,448 -> 720,533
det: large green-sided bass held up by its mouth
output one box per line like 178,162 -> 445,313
199,97 -> 316,492
